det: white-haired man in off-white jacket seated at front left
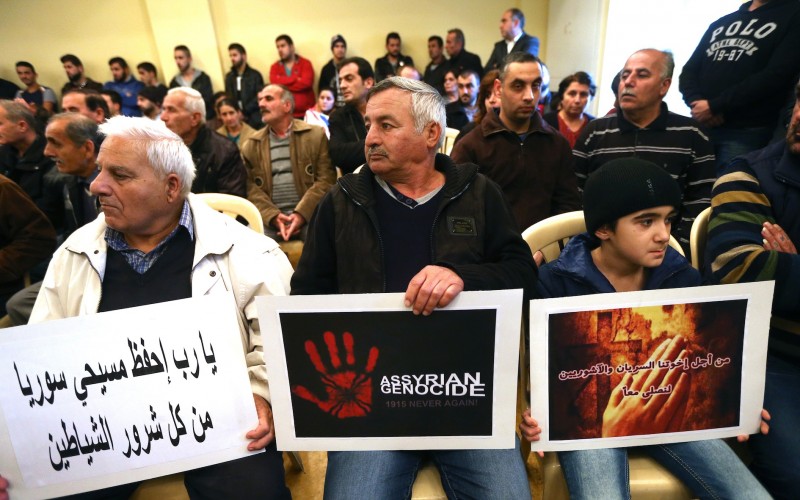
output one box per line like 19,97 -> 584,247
5,116 -> 292,499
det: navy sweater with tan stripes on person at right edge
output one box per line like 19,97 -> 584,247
706,141 -> 800,359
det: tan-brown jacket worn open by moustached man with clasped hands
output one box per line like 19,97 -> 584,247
242,120 -> 336,225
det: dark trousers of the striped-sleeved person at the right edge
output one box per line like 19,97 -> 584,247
750,356 -> 800,499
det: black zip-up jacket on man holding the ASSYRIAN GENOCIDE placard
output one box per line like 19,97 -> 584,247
291,154 -> 536,299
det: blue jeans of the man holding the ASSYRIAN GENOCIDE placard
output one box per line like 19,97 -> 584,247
324,439 -> 531,500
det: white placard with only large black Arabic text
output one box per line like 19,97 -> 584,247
0,295 -> 257,499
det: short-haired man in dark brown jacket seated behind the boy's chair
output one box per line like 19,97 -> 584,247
451,52 -> 580,232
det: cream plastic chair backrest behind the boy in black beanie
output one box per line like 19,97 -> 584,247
522,210 -> 684,262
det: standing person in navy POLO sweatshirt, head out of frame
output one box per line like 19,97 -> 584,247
679,0 -> 800,167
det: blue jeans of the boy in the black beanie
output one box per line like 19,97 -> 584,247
558,439 -> 770,500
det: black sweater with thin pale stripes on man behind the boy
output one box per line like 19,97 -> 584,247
572,103 -> 716,258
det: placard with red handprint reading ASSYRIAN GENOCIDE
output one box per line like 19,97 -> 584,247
256,290 -> 522,450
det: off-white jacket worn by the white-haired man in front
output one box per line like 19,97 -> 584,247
30,194 -> 292,401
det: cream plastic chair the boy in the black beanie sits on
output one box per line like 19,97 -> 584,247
520,210 -> 692,500
